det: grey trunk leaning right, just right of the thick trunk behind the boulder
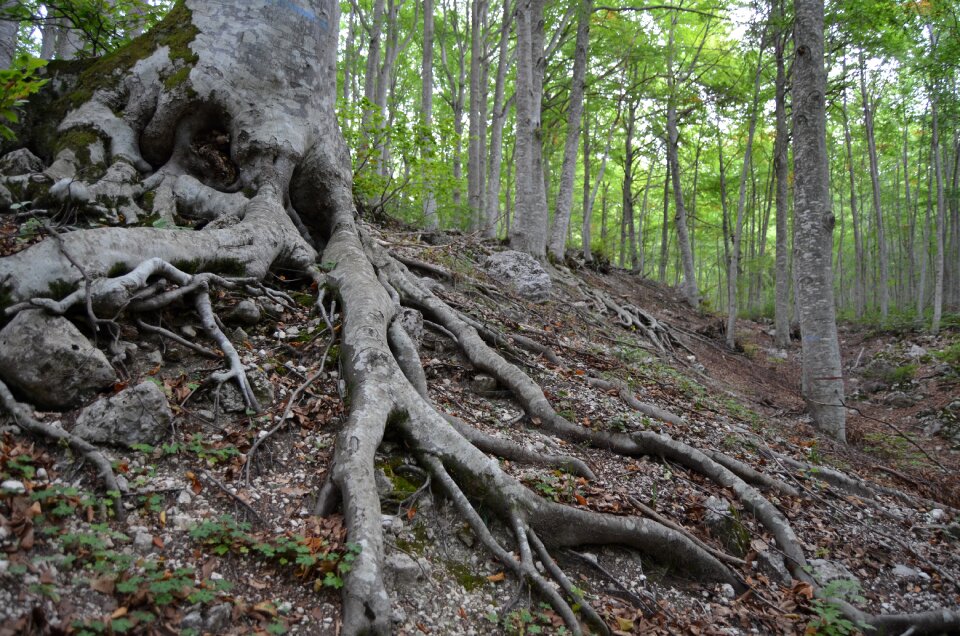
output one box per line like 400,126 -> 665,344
549,0 -> 593,260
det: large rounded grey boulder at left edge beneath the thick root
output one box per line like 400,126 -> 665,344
0,310 -> 117,409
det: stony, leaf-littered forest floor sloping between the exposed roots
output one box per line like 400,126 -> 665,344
0,219 -> 960,635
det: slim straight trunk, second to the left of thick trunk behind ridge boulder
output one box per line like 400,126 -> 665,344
467,0 -> 487,231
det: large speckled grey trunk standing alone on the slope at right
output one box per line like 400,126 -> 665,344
793,0 -> 846,441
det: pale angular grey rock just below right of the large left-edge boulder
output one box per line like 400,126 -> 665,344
73,381 -> 173,447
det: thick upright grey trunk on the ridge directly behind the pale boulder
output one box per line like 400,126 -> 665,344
510,0 -> 548,259
